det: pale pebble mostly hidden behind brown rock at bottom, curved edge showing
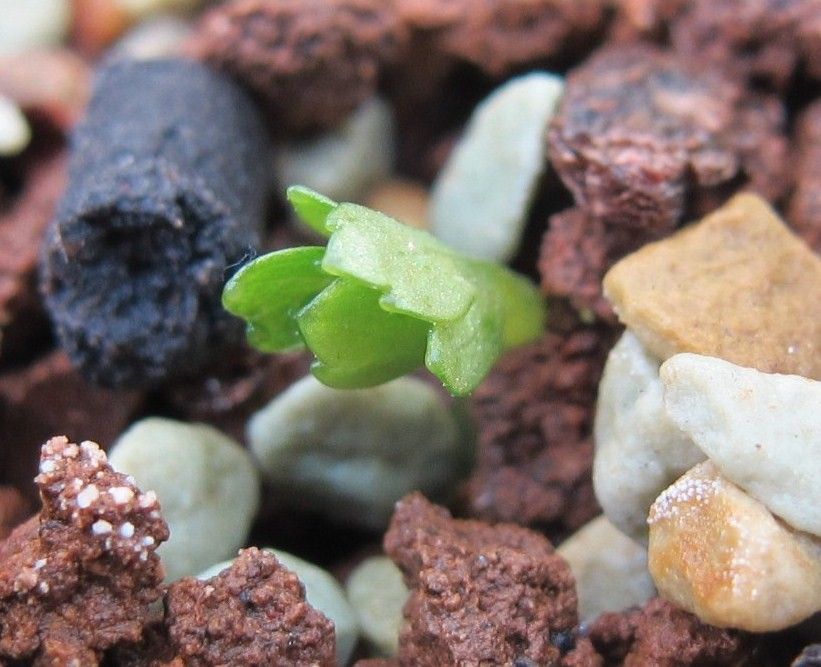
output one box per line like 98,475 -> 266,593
197,547 -> 360,666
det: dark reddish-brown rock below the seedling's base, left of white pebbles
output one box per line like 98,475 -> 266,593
466,303 -> 616,535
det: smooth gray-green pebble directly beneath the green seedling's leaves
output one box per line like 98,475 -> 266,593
248,376 -> 469,530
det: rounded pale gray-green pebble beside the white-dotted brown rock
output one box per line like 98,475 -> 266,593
109,417 -> 259,581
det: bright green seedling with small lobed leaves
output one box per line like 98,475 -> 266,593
222,187 -> 545,396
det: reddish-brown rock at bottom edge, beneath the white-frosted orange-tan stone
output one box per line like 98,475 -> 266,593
589,598 -> 756,667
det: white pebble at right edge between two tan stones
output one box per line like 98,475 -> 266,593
660,354 -> 821,536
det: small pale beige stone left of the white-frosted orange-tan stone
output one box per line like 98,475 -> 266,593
556,516 -> 656,622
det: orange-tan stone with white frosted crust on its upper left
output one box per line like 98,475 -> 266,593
648,461 -> 821,632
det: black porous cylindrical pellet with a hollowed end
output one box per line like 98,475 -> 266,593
41,60 -> 268,388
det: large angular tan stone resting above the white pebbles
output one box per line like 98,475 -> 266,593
604,194 -> 821,379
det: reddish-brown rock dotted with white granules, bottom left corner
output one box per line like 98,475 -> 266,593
0,436 -> 168,667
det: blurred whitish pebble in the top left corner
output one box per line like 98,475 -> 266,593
0,0 -> 71,54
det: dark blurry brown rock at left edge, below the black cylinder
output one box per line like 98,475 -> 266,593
0,352 -> 143,500
